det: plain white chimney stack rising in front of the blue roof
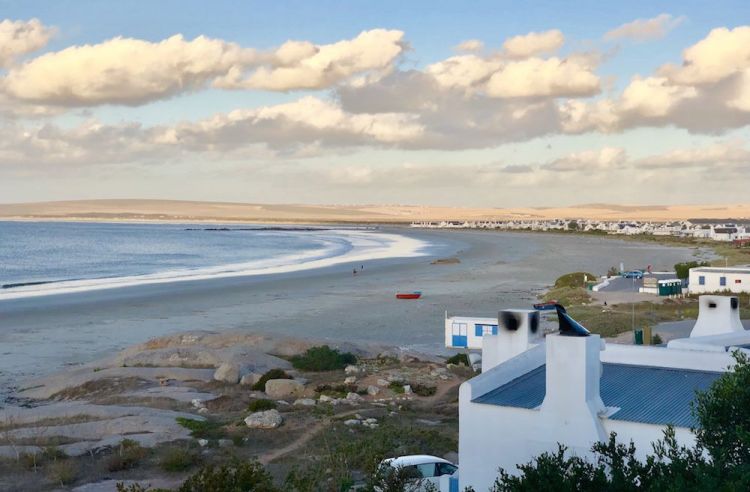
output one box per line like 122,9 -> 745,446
540,334 -> 607,452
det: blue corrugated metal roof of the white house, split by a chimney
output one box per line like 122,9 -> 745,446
472,363 -> 721,427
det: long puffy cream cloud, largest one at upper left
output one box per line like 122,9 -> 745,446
3,35 -> 255,106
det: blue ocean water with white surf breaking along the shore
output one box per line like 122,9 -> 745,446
0,222 -> 428,300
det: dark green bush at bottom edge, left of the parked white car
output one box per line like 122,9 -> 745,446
178,461 -> 278,492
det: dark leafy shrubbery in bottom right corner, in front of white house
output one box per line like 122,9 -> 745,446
484,351 -> 750,492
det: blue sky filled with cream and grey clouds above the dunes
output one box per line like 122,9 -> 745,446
0,0 -> 750,207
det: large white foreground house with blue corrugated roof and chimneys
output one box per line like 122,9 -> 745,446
458,301 -> 750,491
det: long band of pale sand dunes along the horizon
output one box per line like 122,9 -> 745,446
0,200 -> 750,223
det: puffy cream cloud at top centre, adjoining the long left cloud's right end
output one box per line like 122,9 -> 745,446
214,29 -> 406,91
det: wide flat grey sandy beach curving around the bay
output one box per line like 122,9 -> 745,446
0,228 -> 693,400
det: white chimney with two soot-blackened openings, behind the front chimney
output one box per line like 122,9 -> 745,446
482,309 -> 543,372
